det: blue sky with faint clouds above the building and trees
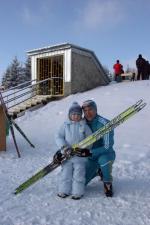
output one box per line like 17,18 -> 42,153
0,0 -> 150,82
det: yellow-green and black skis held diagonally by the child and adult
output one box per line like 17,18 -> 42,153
14,100 -> 146,194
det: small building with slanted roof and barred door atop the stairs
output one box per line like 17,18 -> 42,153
27,43 -> 110,96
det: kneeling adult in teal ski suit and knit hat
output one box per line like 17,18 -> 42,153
82,100 -> 115,197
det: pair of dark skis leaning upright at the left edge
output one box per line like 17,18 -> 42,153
0,92 -> 35,158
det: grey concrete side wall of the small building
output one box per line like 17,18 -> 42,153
71,52 -> 108,93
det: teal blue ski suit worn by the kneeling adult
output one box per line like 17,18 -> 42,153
86,115 -> 115,184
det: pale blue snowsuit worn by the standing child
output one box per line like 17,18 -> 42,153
56,119 -> 92,196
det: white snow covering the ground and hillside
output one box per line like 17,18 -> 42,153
0,81 -> 150,225
